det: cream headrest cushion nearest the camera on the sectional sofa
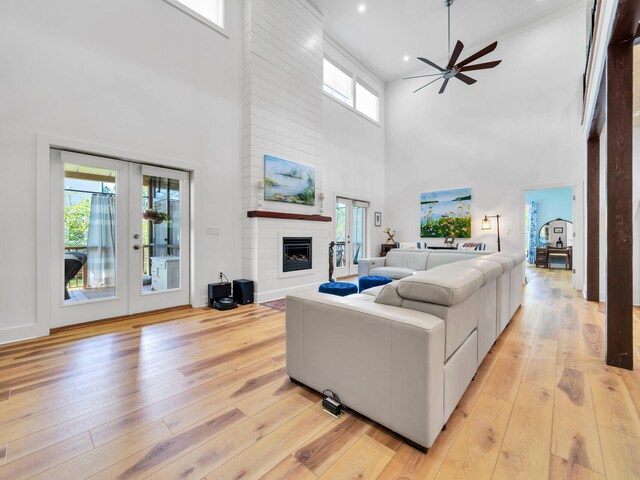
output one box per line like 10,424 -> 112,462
397,264 -> 484,306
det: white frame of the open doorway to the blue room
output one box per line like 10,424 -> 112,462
518,182 -> 584,290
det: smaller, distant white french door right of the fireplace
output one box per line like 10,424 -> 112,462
333,197 -> 369,278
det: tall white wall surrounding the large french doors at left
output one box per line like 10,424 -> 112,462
0,0 -> 242,342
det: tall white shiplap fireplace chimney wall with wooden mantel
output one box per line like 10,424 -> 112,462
242,0 -> 332,301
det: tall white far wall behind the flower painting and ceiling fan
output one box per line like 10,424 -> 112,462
386,9 -> 586,276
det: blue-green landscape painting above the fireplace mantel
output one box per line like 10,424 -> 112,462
264,155 -> 316,205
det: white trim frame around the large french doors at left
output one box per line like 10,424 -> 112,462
26,133 -> 199,342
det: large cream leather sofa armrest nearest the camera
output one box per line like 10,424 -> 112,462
286,292 -> 445,448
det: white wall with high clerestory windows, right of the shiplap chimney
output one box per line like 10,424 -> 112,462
323,36 -> 387,257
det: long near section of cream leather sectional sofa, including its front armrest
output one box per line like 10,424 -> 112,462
286,253 -> 524,449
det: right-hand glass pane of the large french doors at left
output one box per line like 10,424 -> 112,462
141,175 -> 181,293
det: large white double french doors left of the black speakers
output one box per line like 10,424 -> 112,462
49,150 -> 189,327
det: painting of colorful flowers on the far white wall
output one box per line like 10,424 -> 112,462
420,188 -> 471,238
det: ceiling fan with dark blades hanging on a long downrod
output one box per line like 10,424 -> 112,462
403,0 -> 502,93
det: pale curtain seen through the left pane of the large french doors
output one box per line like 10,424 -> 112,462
87,193 -> 116,288
